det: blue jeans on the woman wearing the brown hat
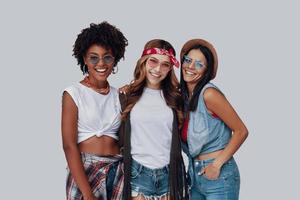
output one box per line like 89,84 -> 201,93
189,158 -> 240,200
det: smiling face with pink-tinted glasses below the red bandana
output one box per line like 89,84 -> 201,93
145,54 -> 172,89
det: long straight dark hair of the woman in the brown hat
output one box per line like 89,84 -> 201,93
180,45 -> 215,111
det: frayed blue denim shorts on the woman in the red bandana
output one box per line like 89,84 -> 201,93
130,160 -> 169,199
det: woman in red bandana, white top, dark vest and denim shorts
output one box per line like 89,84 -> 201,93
120,39 -> 187,200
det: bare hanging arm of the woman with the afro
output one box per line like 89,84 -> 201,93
61,92 -> 96,200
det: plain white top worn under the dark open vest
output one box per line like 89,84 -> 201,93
130,88 -> 173,169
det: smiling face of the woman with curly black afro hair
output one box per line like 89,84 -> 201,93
84,44 -> 114,82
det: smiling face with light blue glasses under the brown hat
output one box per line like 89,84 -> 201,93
182,49 -> 207,87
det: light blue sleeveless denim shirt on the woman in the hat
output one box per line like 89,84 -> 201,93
183,83 -> 232,158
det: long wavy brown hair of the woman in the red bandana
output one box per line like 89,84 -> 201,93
122,39 -> 183,127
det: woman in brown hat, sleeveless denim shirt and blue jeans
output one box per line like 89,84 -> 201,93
180,39 -> 248,200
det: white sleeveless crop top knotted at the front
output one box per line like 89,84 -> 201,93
64,83 -> 121,143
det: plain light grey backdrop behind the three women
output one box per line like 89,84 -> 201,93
0,0 -> 300,200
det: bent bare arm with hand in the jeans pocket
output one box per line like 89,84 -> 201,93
200,88 -> 248,178
